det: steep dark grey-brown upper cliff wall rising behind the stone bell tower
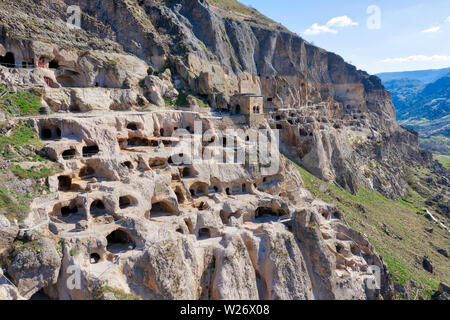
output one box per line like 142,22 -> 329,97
48,0 -> 432,198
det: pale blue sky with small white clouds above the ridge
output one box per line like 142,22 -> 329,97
240,0 -> 450,73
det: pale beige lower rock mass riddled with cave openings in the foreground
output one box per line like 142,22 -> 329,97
7,110 -> 393,300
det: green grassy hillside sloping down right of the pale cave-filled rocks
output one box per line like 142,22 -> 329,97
288,158 -> 450,299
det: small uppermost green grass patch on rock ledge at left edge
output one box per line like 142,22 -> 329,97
0,87 -> 41,115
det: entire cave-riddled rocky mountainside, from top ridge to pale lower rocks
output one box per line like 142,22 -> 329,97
0,0 -> 442,299
